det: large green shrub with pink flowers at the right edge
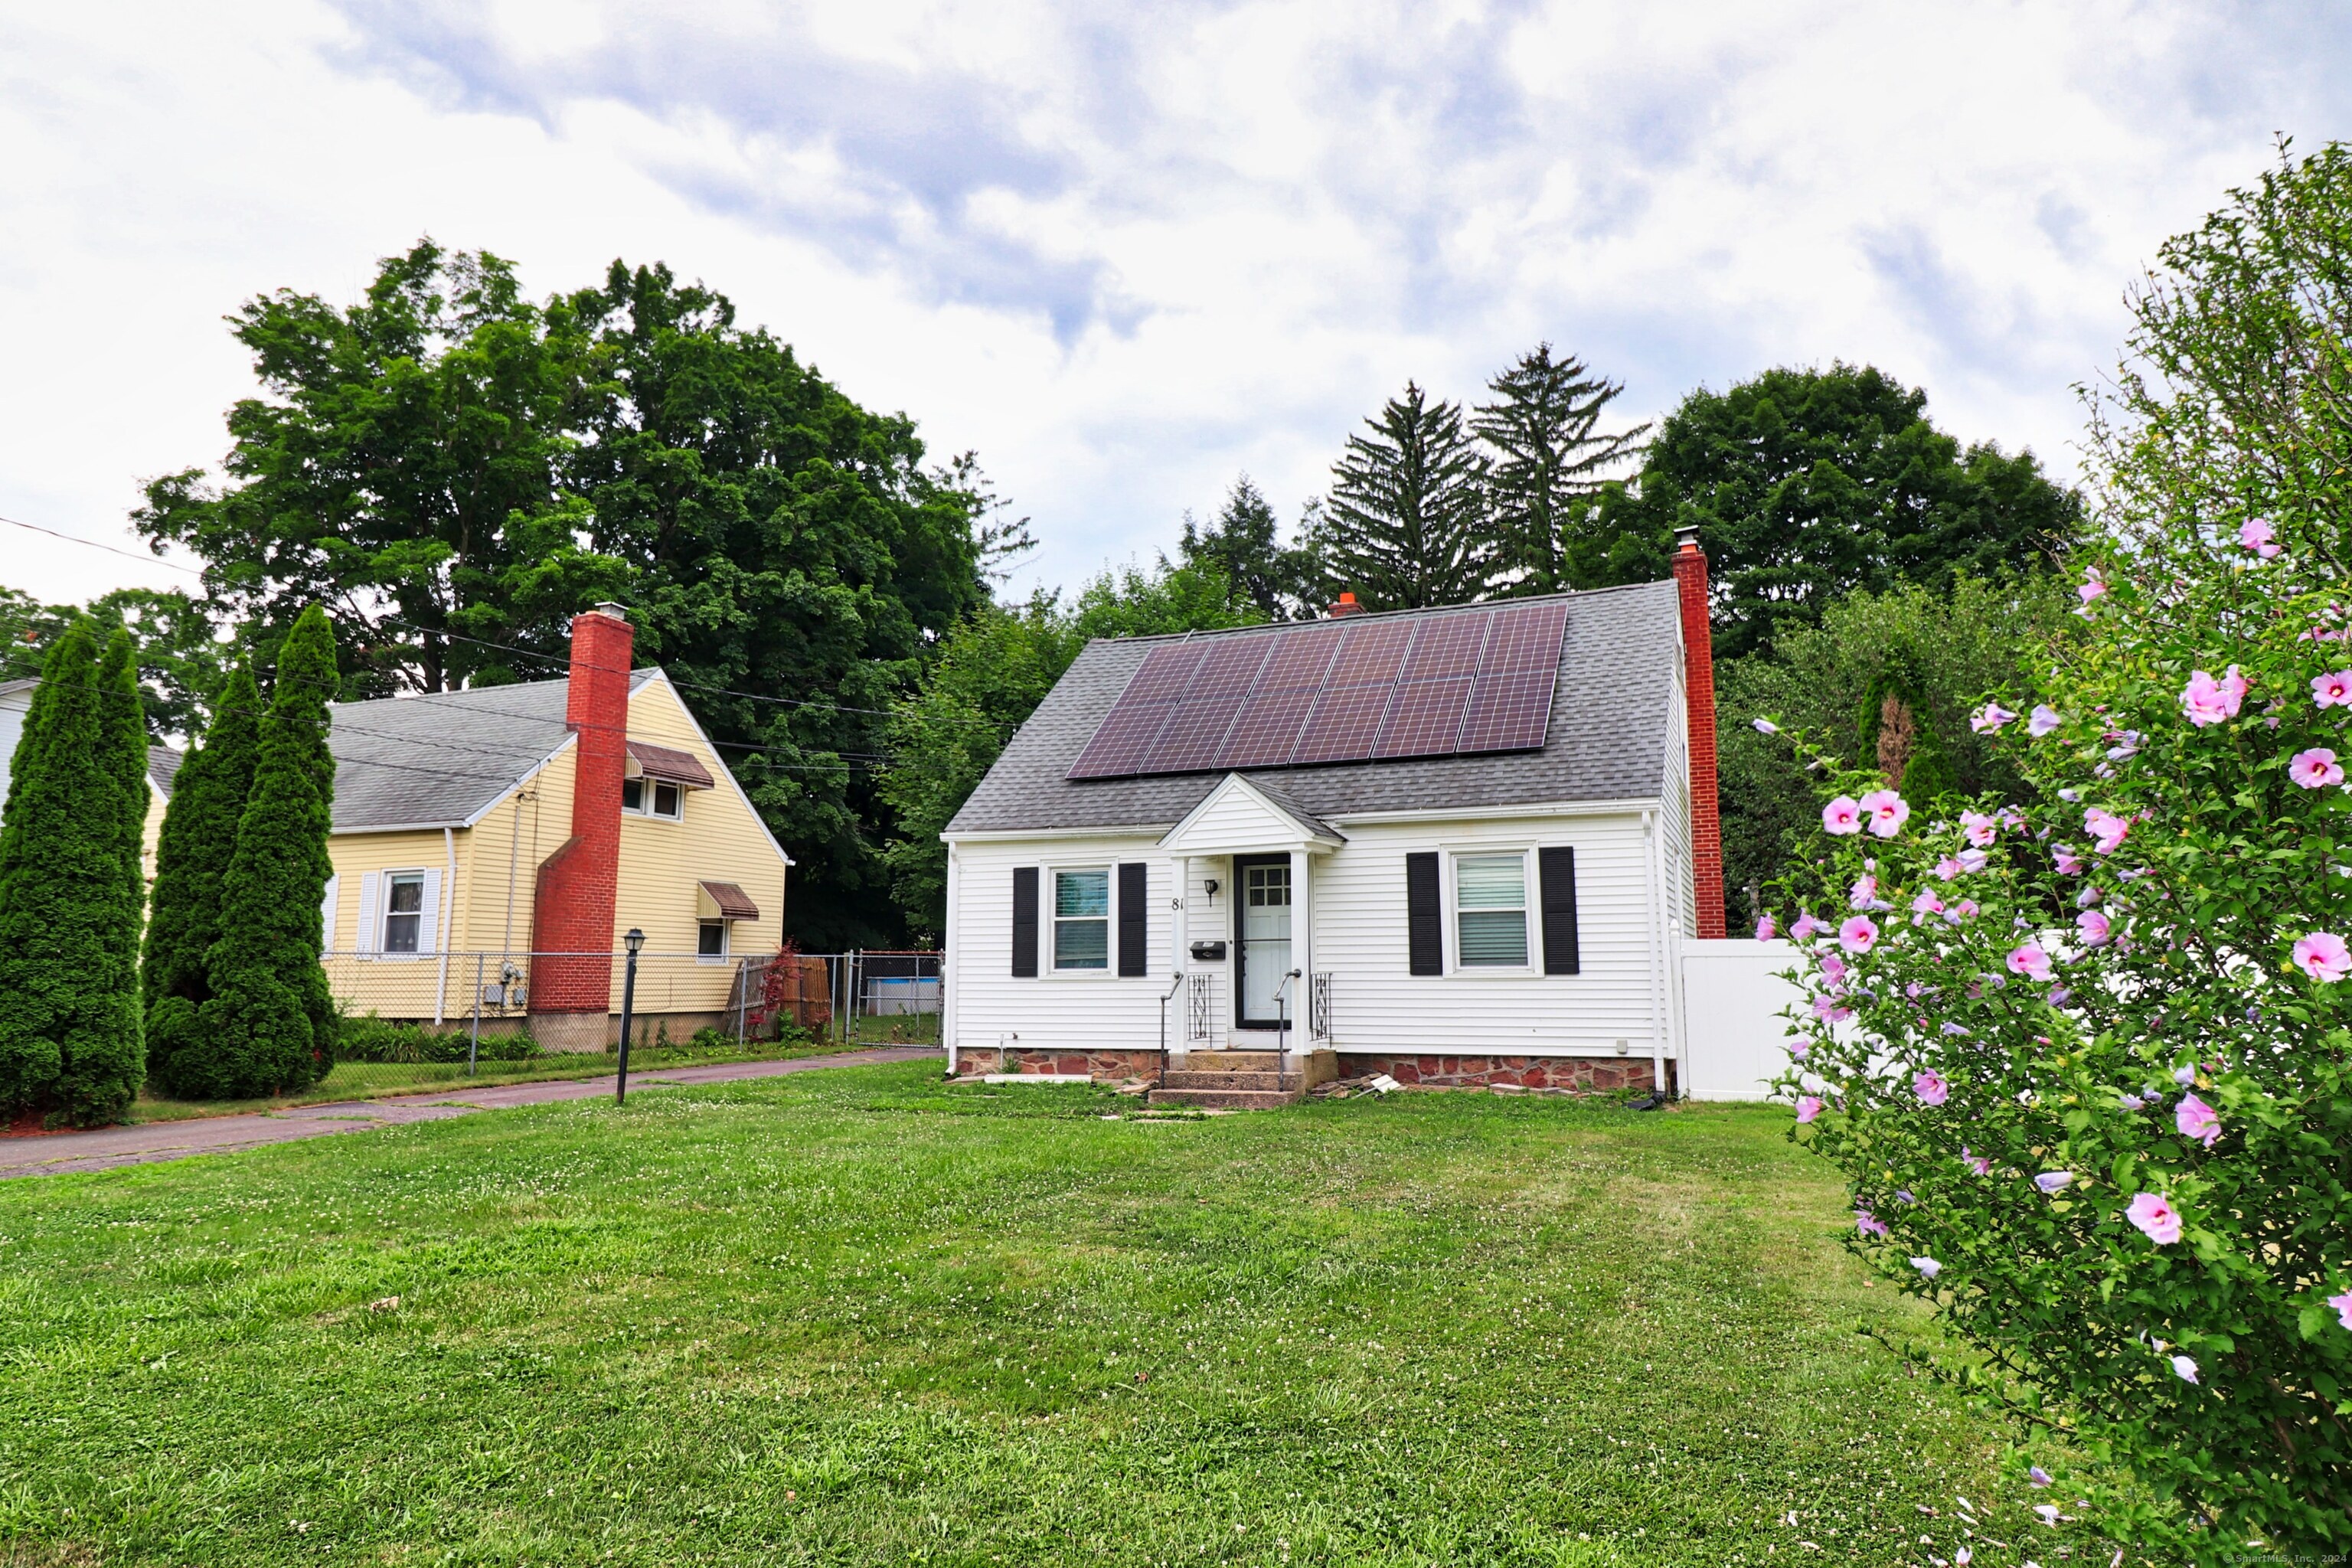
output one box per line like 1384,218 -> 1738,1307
1783,148 -> 2352,1561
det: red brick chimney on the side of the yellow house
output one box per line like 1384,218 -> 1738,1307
531,604 -> 635,1050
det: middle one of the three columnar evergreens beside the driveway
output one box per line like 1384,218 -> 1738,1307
139,668 -> 261,1096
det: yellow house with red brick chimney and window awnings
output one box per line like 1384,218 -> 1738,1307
325,639 -> 792,1048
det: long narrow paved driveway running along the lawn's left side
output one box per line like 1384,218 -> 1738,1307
0,1046 -> 939,1175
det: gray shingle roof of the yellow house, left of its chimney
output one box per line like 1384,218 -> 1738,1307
327,670 -> 656,832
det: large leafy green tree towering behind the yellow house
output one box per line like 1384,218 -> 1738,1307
136,240 -> 992,945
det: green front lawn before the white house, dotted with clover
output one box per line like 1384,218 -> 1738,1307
0,1063 -> 2056,1566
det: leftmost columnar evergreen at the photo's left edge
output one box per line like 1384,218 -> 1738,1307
0,621 -> 145,1126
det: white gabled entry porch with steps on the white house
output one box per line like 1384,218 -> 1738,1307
1155,773 -> 1348,1105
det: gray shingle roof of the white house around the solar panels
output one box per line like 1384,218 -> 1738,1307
948,583 -> 1681,835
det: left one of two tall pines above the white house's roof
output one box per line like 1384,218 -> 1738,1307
1310,381 -> 1496,609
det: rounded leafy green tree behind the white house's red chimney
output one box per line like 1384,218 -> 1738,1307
1571,364 -> 2082,656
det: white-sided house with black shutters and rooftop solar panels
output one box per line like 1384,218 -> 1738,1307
943,541 -> 1759,1105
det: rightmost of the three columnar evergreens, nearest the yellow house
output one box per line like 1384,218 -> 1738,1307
192,604 -> 341,1098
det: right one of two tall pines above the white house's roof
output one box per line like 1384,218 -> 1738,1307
1470,343 -> 1648,593
